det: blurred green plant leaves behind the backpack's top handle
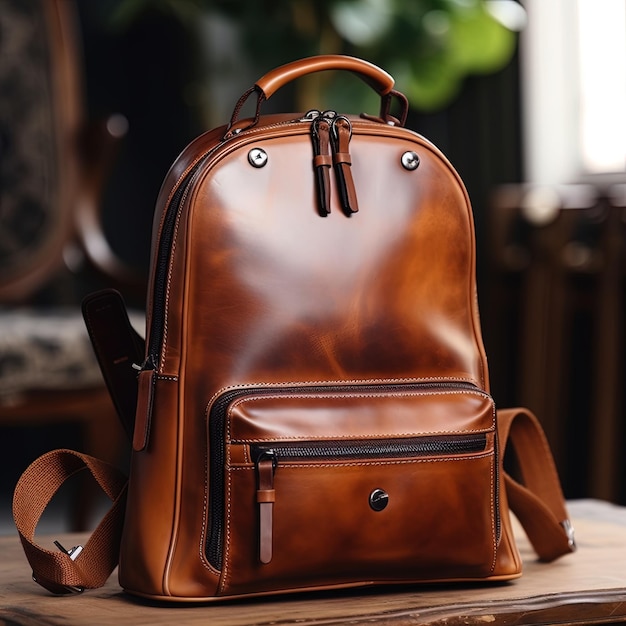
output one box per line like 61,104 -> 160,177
111,0 -> 524,111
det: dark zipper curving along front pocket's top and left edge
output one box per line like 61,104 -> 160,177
205,381 -> 488,570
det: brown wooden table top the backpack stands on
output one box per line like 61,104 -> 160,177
0,501 -> 626,626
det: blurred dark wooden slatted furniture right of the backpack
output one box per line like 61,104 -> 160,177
482,184 -> 626,504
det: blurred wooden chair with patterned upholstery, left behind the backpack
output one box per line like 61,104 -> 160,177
0,0 -> 140,529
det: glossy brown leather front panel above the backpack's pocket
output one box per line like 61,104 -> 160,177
178,125 -> 486,388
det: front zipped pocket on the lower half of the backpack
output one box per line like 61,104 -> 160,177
206,381 -> 499,594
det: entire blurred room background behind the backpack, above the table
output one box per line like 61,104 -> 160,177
0,0 -> 626,532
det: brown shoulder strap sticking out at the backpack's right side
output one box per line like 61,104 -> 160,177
498,408 -> 576,561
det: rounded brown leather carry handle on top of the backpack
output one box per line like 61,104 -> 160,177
224,54 -> 409,139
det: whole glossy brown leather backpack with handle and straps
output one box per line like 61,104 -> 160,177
16,56 -> 573,601
